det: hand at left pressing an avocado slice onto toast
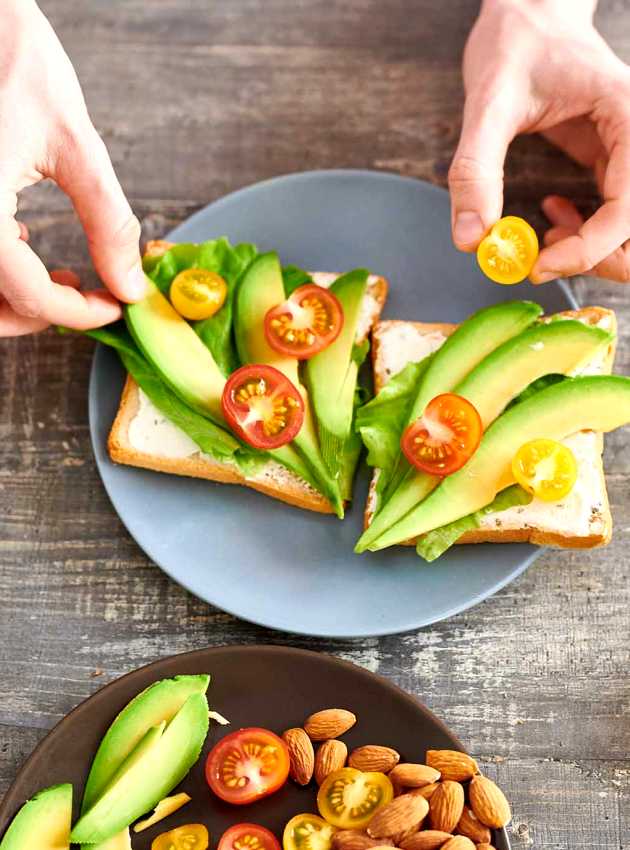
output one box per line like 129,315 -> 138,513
0,0 -> 145,337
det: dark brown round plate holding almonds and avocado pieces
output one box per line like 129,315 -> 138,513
0,646 -> 510,850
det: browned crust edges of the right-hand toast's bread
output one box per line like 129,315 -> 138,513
363,307 -> 617,549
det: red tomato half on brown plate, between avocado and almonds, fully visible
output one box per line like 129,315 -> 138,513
206,727 -> 289,805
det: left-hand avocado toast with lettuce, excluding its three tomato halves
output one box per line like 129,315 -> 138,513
97,240 -> 387,516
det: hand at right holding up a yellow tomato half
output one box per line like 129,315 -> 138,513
449,0 -> 630,283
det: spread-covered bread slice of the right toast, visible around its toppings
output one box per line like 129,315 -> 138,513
365,307 -> 616,549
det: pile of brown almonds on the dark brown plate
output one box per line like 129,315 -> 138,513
282,708 -> 512,850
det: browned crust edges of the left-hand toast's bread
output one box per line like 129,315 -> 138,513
107,252 -> 388,514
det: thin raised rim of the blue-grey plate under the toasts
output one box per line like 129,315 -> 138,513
88,168 -> 578,640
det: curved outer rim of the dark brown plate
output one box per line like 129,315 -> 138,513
0,643 -> 511,850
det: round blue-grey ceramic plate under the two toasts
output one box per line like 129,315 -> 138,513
90,171 -> 572,637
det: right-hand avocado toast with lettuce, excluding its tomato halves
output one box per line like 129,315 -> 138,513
357,302 -> 628,560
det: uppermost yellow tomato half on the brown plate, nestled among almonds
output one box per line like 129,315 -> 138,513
317,767 -> 394,829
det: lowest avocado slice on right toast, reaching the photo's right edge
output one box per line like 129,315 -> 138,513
370,375 -> 630,551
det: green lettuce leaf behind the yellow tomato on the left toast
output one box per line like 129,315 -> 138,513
145,237 -> 258,377
